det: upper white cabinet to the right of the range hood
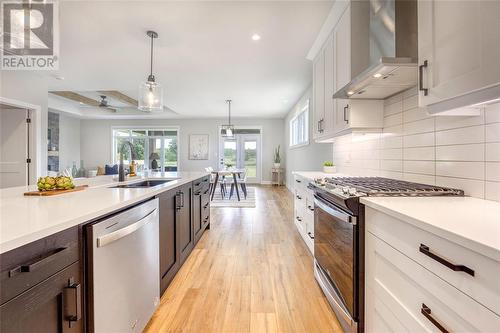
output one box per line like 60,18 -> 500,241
418,0 -> 500,113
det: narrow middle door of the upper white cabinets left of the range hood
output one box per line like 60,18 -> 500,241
321,33 -> 336,136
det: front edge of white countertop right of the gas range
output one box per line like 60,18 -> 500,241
360,198 -> 500,262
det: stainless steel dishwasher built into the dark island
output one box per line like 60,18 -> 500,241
87,199 -> 160,333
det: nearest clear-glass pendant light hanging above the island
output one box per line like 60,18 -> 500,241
138,31 -> 163,112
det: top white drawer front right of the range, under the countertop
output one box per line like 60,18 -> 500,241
366,207 -> 500,315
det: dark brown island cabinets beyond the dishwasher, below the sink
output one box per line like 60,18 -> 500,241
158,176 -> 210,294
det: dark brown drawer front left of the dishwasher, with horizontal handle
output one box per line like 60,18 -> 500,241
0,227 -> 80,304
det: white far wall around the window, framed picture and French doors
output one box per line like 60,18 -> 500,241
80,118 -> 283,181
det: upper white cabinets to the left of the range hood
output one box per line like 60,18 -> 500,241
313,1 -> 383,141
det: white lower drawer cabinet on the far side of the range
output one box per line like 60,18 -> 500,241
293,175 -> 314,254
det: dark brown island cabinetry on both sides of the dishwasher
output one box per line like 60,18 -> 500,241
0,176 -> 210,333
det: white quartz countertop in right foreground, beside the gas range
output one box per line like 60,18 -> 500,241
361,197 -> 500,261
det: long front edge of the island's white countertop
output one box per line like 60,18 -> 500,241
0,172 -> 209,255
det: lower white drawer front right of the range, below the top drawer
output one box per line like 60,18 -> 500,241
366,232 -> 500,332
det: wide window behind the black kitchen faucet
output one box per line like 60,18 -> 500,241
113,128 -> 179,171
